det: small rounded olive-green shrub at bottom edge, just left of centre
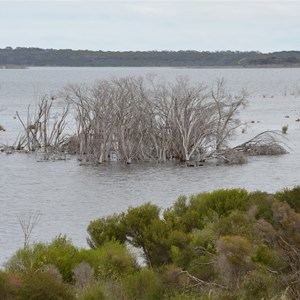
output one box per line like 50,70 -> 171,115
122,269 -> 163,300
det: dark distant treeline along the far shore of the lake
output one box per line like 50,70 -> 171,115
0,47 -> 300,67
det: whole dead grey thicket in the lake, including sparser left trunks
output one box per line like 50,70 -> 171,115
8,75 -> 288,164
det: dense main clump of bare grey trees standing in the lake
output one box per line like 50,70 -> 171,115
66,77 -> 247,163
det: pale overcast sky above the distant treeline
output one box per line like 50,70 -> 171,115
0,0 -> 300,52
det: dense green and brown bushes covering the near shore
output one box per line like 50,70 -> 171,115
0,186 -> 300,300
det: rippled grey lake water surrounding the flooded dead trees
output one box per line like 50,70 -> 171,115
0,68 -> 300,265
